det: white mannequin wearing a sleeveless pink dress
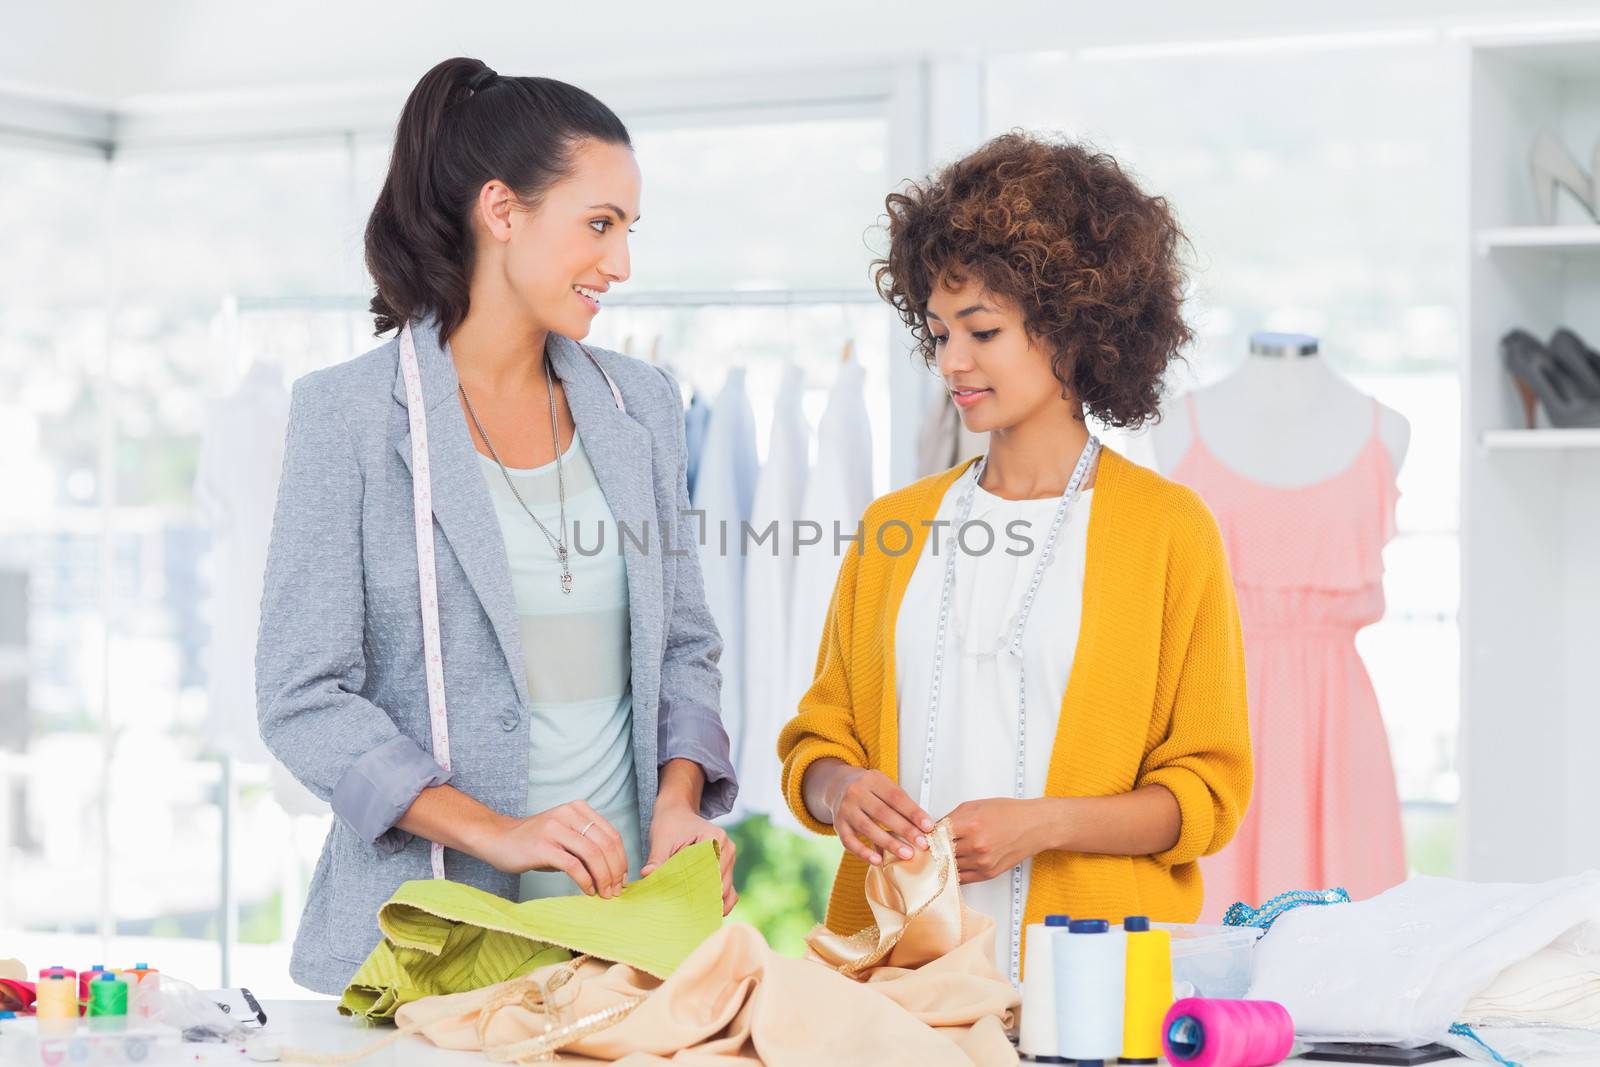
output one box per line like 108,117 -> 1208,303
1152,334 -> 1411,923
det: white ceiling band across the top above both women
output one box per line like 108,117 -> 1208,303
9,0 -> 1600,104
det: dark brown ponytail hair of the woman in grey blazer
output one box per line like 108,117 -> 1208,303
366,58 -> 632,339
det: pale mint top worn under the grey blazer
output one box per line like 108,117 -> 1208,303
478,430 -> 645,901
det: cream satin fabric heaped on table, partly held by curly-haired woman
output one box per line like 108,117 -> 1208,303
380,822 -> 1018,1067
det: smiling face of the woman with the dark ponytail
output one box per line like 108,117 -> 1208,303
475,141 -> 640,341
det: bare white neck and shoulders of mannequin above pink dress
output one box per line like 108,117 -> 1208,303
1150,333 -> 1411,490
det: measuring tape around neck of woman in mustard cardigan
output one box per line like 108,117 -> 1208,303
920,434 -> 1101,985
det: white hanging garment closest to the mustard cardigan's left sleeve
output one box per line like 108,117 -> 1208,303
787,362 -> 893,735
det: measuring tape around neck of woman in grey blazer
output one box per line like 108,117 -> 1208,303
400,323 -> 627,878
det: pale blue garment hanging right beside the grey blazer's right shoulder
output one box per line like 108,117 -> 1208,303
682,366 -> 758,781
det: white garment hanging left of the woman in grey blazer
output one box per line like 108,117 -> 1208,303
194,363 -> 328,814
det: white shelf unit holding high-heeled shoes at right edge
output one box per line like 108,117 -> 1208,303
1459,35 -> 1600,881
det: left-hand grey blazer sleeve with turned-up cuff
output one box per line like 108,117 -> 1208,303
256,379 -> 450,853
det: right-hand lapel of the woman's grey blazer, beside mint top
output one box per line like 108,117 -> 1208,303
549,334 -> 659,713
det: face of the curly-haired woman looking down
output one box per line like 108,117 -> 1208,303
926,278 -> 1064,434
